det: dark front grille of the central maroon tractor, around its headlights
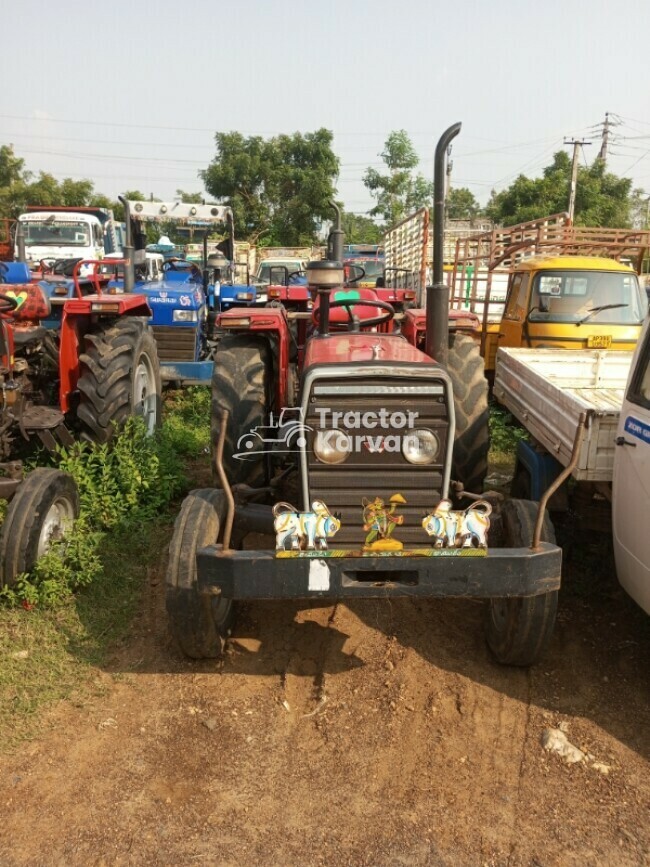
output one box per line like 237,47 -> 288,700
303,367 -> 453,547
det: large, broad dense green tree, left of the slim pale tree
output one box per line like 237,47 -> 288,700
200,129 -> 339,246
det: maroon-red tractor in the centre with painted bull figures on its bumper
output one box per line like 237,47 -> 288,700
167,124 -> 561,665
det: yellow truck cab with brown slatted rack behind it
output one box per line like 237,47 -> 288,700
452,215 -> 650,372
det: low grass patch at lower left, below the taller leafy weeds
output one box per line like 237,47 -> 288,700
0,515 -> 173,750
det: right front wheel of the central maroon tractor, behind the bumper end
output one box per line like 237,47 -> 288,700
485,500 -> 558,665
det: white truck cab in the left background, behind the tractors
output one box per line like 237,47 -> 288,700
15,207 -> 122,271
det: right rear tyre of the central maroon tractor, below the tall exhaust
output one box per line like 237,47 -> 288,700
447,332 -> 490,494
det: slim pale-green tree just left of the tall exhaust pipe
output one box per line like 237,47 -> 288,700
363,129 -> 433,225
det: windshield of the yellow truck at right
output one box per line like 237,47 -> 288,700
528,271 -> 647,325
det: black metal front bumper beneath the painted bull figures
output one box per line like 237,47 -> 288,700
196,542 -> 562,599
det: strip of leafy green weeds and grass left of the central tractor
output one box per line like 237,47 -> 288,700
0,388 -> 209,749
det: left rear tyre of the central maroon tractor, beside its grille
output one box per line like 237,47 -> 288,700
210,334 -> 271,488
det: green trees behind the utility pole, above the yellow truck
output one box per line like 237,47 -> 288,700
485,151 -> 633,227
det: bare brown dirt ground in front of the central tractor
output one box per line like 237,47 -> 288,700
0,536 -> 650,867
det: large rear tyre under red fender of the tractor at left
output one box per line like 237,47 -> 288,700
77,316 -> 162,443
